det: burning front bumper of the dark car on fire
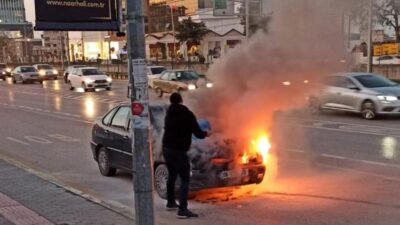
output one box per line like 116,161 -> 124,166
190,164 -> 266,191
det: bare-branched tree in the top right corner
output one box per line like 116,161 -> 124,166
376,0 -> 400,42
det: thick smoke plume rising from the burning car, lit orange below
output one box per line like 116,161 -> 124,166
186,0 -> 356,193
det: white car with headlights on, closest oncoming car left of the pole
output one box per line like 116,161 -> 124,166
68,67 -> 112,91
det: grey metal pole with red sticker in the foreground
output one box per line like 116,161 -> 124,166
126,0 -> 154,225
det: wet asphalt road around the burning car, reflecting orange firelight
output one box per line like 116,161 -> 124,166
0,78 -> 400,225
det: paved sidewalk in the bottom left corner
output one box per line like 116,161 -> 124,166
0,160 -> 134,225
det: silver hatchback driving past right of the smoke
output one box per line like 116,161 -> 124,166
309,73 -> 400,120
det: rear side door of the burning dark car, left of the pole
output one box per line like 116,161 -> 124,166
107,106 -> 132,170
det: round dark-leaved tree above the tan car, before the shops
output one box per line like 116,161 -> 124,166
176,17 -> 208,45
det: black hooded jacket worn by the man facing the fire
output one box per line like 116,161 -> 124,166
163,104 -> 207,152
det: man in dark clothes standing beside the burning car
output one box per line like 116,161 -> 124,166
163,93 -> 208,219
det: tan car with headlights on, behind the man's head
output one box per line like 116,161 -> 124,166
153,70 -> 213,97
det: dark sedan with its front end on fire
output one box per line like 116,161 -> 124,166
91,105 -> 265,198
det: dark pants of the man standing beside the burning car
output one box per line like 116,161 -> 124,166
163,148 -> 190,210
